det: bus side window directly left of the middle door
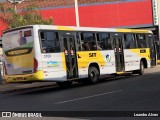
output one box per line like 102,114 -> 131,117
97,33 -> 112,50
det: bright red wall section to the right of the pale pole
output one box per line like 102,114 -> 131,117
79,0 -> 153,27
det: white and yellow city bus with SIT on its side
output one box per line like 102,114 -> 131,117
2,25 -> 156,85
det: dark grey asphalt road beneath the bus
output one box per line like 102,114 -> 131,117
0,73 -> 160,117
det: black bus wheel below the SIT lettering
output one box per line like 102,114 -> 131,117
88,66 -> 100,84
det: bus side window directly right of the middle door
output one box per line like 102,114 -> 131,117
124,34 -> 136,49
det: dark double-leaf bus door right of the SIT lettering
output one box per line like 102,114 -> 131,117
112,36 -> 124,72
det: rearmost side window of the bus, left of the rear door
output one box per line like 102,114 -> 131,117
40,31 -> 61,53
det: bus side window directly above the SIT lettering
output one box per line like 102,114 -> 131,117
81,32 -> 97,51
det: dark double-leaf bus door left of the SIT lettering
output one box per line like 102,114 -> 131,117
62,36 -> 78,79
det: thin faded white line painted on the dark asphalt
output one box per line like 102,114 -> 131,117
54,90 -> 123,104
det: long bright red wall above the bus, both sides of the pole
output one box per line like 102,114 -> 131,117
42,0 -> 153,27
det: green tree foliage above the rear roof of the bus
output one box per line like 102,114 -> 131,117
0,4 -> 53,28
